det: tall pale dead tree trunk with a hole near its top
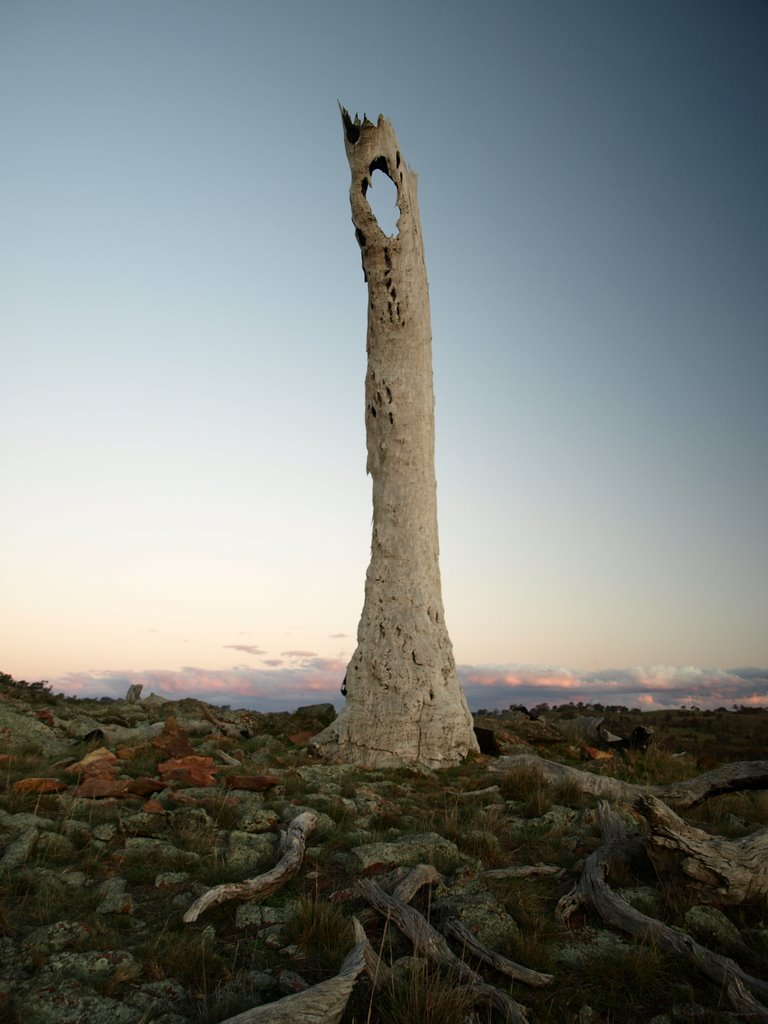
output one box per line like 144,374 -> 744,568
312,110 -> 478,767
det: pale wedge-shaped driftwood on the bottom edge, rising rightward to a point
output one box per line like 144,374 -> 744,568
221,942 -> 366,1024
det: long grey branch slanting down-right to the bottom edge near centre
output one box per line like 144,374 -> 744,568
357,879 -> 526,1024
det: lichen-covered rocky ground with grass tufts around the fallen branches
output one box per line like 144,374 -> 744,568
0,677 -> 768,1024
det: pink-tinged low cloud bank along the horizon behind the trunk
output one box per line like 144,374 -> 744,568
50,651 -> 768,712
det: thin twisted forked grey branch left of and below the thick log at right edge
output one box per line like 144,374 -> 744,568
555,801 -> 768,996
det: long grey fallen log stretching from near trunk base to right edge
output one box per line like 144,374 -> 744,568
488,754 -> 768,810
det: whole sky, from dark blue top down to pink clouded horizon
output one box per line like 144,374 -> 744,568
0,0 -> 768,710
